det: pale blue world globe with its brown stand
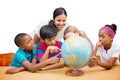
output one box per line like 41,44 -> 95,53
61,36 -> 92,75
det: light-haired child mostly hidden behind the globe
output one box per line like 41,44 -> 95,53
63,26 -> 93,48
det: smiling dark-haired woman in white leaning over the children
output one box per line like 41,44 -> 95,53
33,7 -> 67,44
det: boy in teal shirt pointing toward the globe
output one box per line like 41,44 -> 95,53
5,33 -> 59,74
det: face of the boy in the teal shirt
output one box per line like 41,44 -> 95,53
21,35 -> 34,51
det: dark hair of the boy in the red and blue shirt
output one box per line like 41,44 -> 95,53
39,25 -> 57,40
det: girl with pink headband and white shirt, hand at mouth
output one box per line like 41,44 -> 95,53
91,24 -> 120,69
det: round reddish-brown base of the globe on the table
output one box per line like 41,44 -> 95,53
66,68 -> 84,76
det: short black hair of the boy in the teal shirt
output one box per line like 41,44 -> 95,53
14,33 -> 27,47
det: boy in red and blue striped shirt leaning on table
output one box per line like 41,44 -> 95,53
36,25 -> 64,70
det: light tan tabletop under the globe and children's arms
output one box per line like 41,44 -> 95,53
0,66 -> 120,80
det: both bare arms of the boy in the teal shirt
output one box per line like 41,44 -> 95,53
5,57 -> 59,74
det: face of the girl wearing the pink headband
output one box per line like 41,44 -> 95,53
99,30 -> 113,46
